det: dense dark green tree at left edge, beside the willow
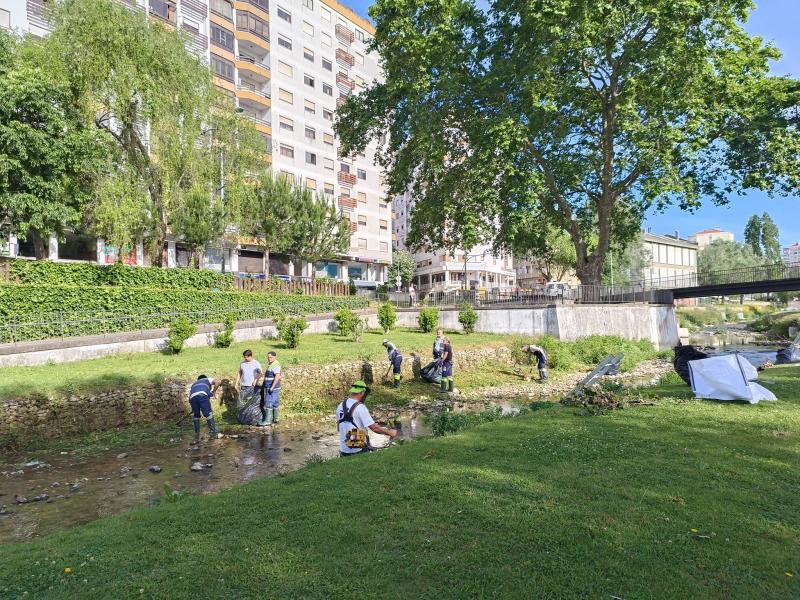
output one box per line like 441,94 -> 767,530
0,28 -> 110,258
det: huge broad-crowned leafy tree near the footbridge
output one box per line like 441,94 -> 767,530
336,0 -> 800,284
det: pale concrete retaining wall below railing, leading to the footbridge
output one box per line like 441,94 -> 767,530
398,304 -> 679,349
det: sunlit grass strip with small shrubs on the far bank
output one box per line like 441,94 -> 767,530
0,330 -> 510,399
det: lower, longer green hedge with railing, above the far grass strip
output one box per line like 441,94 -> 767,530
0,284 -> 369,343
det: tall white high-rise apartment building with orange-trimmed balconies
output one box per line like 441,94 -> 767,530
0,0 -> 392,287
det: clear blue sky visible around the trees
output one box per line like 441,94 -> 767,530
344,0 -> 800,246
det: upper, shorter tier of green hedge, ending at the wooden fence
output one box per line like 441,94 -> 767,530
3,260 -> 233,290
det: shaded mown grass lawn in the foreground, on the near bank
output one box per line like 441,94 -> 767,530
0,367 -> 800,599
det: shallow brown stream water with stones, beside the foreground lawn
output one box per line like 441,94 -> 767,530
0,413 -> 429,543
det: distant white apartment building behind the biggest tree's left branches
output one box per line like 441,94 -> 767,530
392,192 -> 516,292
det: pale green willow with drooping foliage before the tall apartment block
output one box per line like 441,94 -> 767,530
44,0 -> 267,264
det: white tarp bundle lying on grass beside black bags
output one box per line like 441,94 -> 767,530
689,352 -> 777,404
